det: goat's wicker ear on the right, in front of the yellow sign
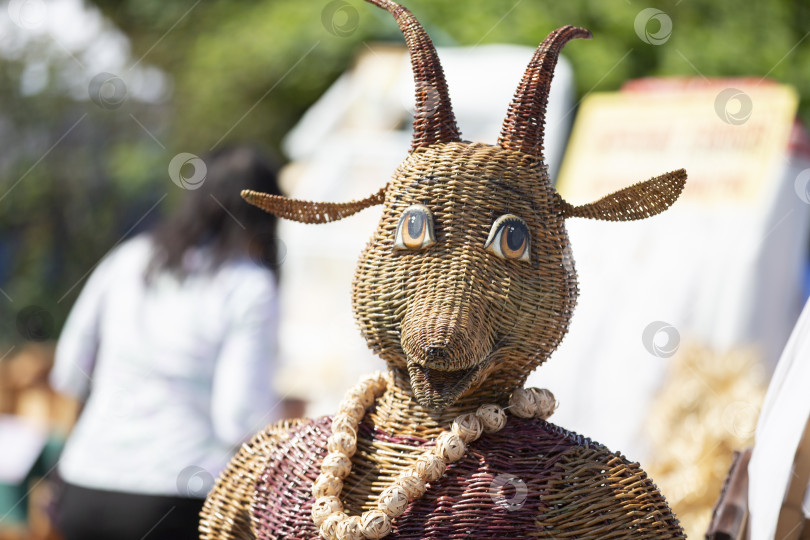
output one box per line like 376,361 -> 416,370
560,169 -> 686,221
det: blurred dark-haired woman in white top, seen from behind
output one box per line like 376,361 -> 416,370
51,147 -> 281,540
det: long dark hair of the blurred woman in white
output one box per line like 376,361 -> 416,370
145,146 -> 281,281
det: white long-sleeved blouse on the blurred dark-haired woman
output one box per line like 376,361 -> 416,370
51,236 -> 281,497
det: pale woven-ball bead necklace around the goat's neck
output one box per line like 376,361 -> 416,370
312,372 -> 557,540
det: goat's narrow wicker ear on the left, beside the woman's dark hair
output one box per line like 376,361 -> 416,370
242,188 -> 386,223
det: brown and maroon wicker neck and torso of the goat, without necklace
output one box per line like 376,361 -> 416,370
201,385 -> 684,540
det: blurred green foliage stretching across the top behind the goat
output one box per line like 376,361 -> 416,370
0,0 -> 810,346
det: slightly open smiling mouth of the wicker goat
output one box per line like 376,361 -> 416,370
408,359 -> 487,410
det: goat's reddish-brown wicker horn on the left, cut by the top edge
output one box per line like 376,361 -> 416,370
366,0 -> 461,152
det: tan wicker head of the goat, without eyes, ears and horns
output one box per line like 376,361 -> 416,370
352,143 -> 577,407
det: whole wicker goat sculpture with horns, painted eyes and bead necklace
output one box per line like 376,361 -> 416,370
200,0 -> 686,539
